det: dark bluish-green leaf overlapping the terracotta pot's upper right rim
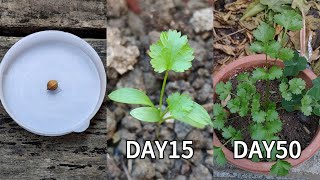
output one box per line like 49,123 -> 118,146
283,51 -> 308,76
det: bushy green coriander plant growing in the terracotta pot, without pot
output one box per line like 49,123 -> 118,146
213,4 -> 320,176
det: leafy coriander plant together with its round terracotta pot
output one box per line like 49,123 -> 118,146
213,5 -> 320,176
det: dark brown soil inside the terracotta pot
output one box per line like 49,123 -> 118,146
215,71 -> 319,160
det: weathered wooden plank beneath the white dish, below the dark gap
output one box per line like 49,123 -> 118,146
0,36 -> 107,180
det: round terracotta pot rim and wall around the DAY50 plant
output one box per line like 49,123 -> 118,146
213,54 -> 320,174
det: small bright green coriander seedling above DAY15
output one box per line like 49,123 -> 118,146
108,30 -> 212,136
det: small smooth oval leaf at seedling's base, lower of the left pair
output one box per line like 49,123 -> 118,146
130,107 -> 161,122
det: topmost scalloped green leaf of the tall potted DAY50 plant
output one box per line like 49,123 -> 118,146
274,10 -> 302,31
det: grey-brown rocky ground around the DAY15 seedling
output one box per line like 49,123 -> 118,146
107,0 -> 213,180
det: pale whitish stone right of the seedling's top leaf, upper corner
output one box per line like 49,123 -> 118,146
190,8 -> 213,33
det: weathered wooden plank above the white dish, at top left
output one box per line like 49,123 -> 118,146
0,0 -> 107,38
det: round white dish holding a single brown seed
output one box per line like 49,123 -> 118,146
0,31 -> 106,136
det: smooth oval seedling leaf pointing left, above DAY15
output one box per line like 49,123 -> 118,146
108,88 -> 154,106
